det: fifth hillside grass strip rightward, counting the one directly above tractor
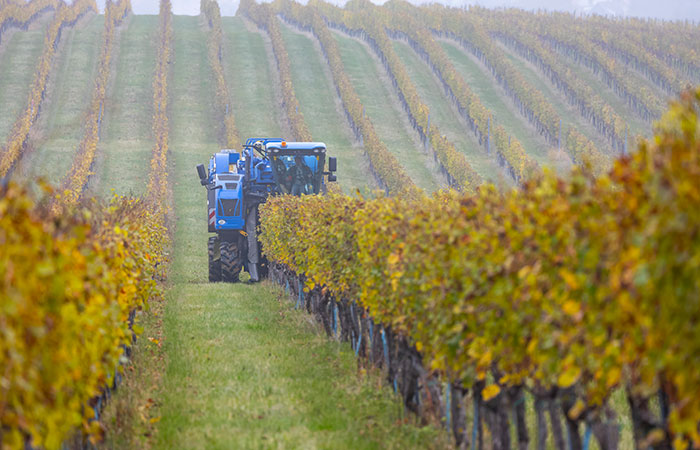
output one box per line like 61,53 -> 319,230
440,41 -> 571,173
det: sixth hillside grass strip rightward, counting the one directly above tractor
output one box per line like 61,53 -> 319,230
494,45 -> 612,153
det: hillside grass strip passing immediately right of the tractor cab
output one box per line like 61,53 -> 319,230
281,24 -> 376,193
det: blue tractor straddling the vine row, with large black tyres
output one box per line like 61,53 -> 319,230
197,138 -> 337,283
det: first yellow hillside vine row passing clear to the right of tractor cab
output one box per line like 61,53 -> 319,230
274,1 -> 418,194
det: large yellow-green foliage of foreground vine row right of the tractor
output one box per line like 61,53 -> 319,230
260,89 -> 700,448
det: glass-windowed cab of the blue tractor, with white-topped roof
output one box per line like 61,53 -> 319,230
266,141 -> 336,196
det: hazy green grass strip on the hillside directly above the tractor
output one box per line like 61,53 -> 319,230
221,17 -> 284,140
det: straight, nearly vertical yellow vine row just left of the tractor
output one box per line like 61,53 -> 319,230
146,0 -> 173,221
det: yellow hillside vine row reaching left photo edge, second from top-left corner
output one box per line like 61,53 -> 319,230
0,0 -> 97,178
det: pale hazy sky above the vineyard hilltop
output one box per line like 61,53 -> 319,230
97,0 -> 700,22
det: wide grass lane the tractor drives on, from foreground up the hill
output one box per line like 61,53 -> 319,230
156,16 -> 443,448
